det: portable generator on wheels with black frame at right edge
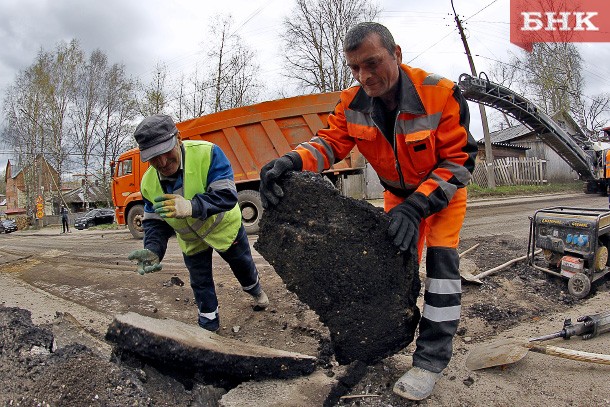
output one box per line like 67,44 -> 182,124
527,206 -> 610,298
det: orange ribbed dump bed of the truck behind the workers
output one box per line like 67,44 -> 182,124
177,92 -> 364,182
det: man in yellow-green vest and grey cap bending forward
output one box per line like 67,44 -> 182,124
129,115 -> 269,332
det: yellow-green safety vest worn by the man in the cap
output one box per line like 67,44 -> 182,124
141,141 -> 241,256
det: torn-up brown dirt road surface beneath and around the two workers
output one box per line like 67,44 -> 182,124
0,195 -> 610,407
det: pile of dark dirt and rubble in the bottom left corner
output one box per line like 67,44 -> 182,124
0,306 -> 226,406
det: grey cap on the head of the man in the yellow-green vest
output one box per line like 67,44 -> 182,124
133,114 -> 178,161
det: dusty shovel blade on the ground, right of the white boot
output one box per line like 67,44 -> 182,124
466,338 -> 529,370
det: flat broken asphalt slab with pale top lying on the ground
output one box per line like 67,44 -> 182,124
106,312 -> 317,381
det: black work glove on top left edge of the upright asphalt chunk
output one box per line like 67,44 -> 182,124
260,151 -> 303,209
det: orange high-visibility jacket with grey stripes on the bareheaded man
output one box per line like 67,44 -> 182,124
295,65 -> 477,216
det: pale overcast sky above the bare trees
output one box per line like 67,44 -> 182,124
0,0 -> 610,168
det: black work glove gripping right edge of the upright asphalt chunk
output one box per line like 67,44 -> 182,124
388,199 -> 424,258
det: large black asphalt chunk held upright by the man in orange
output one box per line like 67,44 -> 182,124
254,172 -> 420,364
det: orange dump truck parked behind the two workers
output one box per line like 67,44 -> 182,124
112,92 -> 365,238
